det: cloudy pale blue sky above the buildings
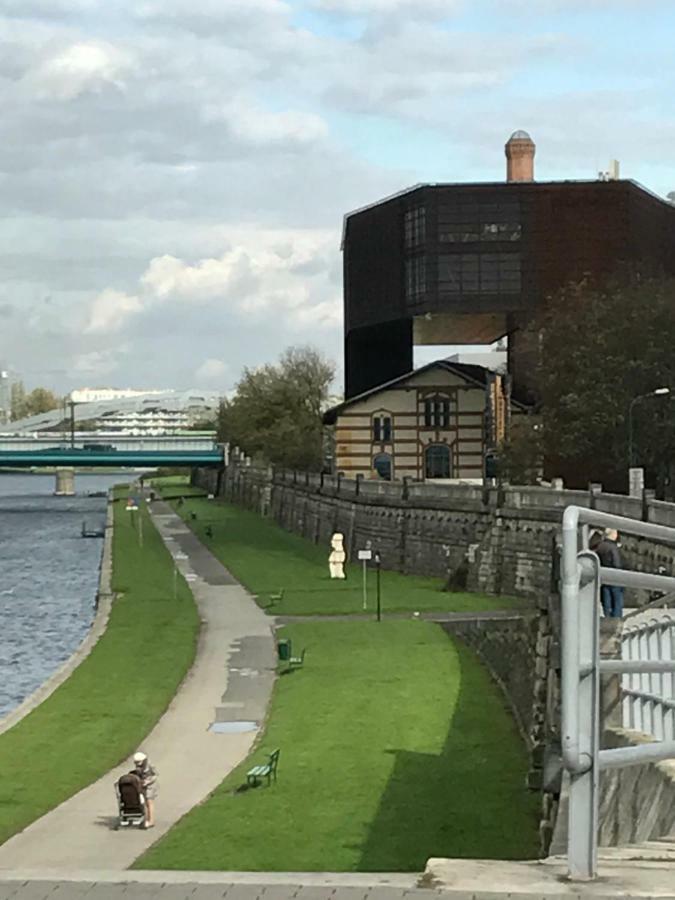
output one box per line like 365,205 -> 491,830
0,0 -> 675,392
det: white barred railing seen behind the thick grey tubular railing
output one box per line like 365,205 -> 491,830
621,610 -> 675,741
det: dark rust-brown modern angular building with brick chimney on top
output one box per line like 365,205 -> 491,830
343,132 -> 675,398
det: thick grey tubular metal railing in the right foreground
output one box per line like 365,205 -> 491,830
561,506 -> 675,880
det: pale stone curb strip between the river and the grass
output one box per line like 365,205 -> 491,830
0,497 -> 115,735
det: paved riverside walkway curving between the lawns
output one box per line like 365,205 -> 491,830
0,503 -> 276,872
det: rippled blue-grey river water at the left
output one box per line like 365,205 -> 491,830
0,473 -> 129,719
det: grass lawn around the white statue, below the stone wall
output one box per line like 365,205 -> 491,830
165,486 -> 526,615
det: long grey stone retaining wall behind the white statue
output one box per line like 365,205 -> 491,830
195,454 -> 675,604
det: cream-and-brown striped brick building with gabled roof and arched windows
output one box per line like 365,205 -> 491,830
324,360 -> 526,482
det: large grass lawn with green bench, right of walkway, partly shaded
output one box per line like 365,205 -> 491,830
135,620 -> 538,871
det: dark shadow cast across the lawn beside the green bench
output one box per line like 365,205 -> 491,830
358,646 -> 538,872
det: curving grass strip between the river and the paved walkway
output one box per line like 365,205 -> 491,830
0,492 -> 199,844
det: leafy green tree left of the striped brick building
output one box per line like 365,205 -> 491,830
218,347 -> 335,470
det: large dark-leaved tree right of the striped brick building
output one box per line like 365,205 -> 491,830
534,276 -> 675,496
